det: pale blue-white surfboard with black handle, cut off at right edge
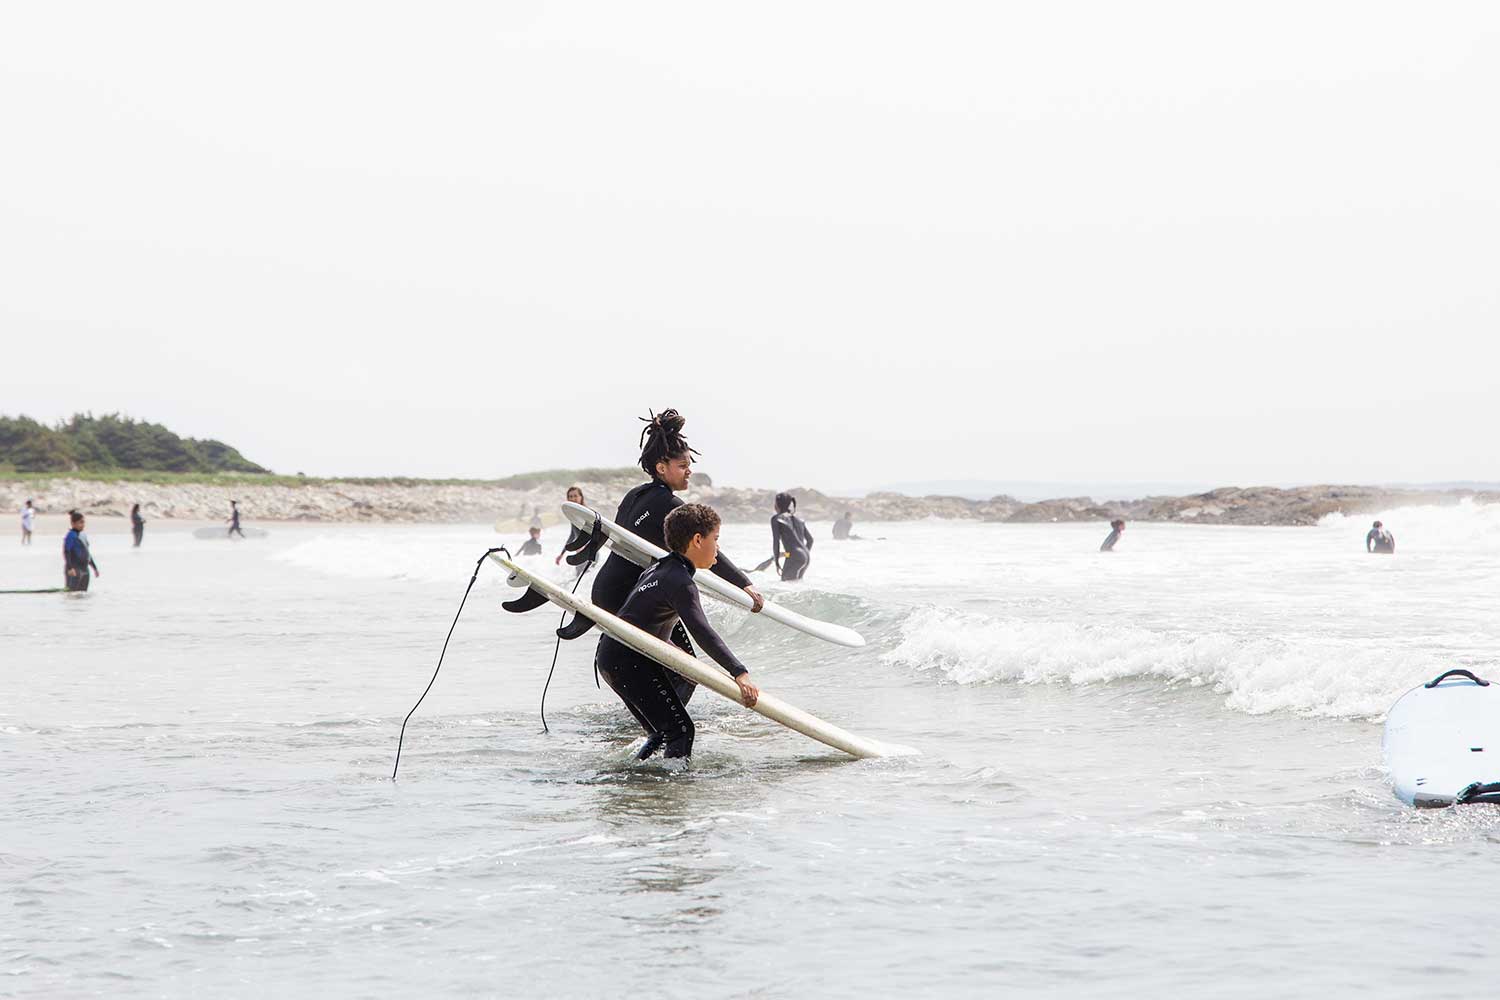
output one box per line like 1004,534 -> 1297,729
1385,670 -> 1500,807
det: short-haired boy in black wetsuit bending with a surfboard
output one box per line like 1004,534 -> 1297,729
597,504 -> 761,760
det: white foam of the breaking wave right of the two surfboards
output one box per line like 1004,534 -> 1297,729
885,607 -> 1449,718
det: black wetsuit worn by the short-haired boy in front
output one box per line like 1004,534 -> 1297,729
596,552 -> 747,757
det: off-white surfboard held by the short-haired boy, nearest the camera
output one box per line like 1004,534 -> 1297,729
489,553 -> 915,757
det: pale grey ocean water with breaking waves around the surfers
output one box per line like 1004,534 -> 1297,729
0,507 -> 1500,997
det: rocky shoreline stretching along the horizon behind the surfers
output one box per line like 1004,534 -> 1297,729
0,477 -> 1500,531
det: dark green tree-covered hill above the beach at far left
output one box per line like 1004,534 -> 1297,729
0,414 -> 267,477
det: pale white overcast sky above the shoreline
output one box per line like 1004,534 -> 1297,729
0,0 -> 1500,487
